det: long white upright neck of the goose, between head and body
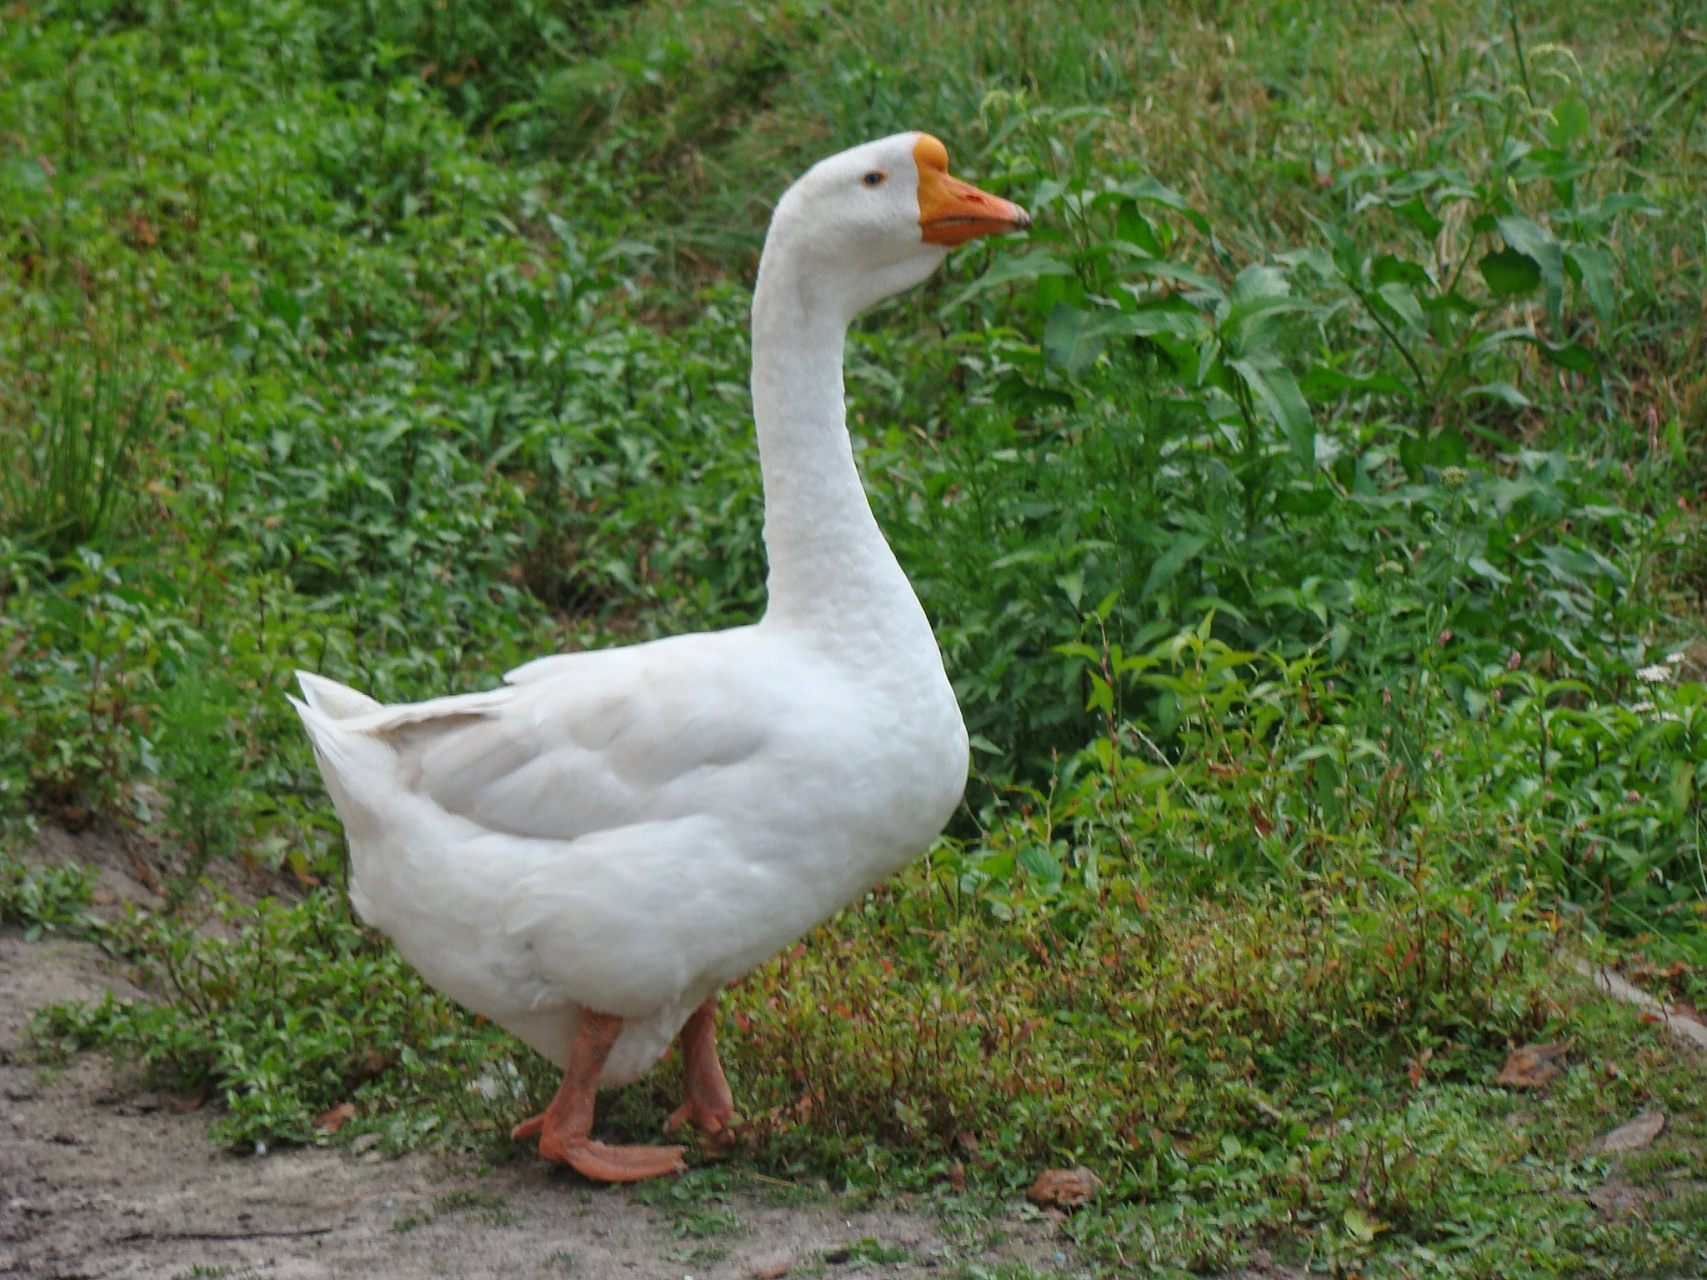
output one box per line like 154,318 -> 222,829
753,236 -> 934,650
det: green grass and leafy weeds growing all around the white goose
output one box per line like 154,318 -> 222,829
0,0 -> 1707,1277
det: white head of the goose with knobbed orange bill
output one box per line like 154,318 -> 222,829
760,133 -> 1031,321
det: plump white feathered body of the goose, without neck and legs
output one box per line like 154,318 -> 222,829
293,604 -> 966,1085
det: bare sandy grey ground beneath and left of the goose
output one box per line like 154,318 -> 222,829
0,831 -> 1079,1280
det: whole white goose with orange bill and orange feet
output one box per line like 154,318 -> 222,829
292,133 -> 1031,1181
